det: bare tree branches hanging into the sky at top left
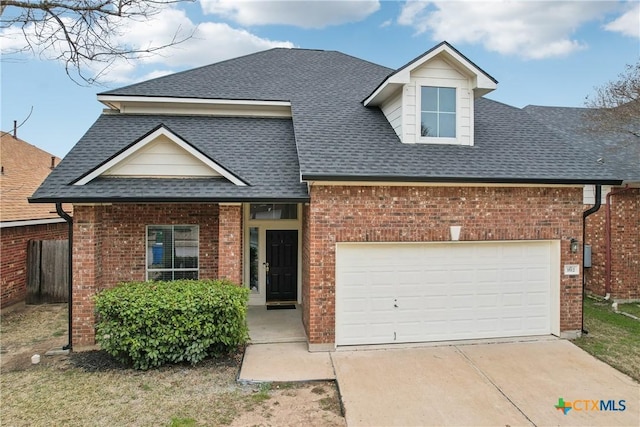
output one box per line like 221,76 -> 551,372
0,0 -> 195,84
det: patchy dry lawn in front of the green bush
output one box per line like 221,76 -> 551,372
0,305 -> 345,427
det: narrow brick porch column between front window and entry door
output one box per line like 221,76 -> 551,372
218,203 -> 242,285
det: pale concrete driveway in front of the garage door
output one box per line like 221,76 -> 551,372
331,340 -> 640,427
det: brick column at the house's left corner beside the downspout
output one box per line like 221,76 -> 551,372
71,205 -> 102,348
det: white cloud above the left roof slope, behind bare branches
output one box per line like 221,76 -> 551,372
0,8 -> 294,84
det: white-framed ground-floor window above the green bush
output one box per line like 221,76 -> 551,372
147,225 -> 200,280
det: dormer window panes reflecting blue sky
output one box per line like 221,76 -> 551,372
420,86 -> 456,138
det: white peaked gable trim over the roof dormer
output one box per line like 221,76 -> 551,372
364,42 -> 498,107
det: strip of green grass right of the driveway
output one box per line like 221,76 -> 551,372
573,298 -> 640,381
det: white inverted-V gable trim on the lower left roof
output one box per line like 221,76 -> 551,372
73,126 -> 247,187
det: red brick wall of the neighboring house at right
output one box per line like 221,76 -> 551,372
585,188 -> 640,300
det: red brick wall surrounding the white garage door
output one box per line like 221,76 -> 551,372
303,186 -> 583,344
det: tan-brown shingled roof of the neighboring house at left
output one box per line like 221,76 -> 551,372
0,132 -> 70,225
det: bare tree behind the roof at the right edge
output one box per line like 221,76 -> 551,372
585,61 -> 640,138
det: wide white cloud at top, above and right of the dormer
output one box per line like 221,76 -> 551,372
398,1 -> 617,59
